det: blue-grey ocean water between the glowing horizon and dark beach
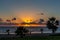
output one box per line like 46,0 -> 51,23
0,27 -> 60,33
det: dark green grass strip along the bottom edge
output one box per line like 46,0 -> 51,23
0,36 -> 60,40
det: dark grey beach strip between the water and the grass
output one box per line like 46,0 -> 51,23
0,33 -> 60,38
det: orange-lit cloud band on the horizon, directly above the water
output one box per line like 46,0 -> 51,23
0,21 -> 60,27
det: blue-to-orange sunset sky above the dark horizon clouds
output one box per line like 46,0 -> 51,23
0,0 -> 60,21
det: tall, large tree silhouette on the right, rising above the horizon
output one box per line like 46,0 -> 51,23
47,17 -> 59,33
